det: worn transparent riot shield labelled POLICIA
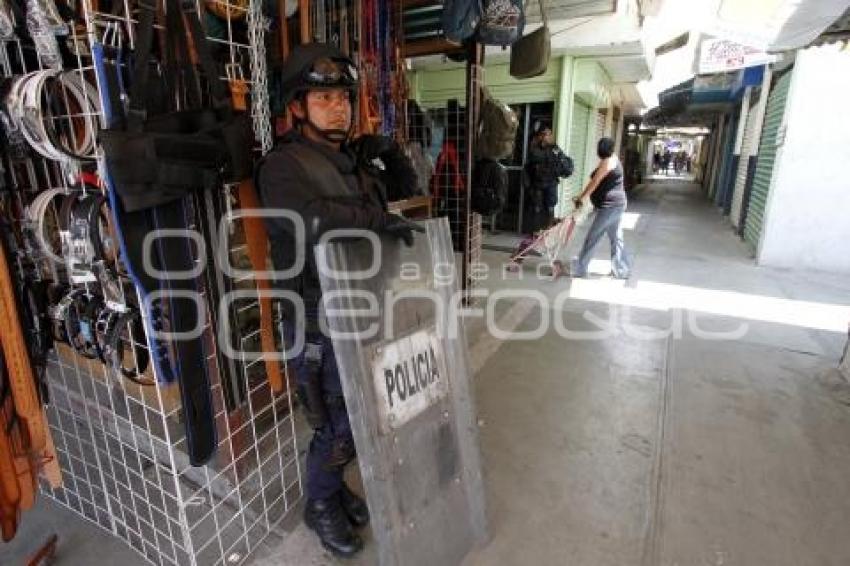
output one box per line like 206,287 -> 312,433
316,218 -> 487,566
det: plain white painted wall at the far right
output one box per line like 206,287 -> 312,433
758,45 -> 850,273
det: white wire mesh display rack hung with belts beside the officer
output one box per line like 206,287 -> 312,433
0,0 -> 302,566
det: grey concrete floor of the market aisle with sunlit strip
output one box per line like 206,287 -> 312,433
0,181 -> 850,566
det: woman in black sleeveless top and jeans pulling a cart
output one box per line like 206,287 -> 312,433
570,138 -> 631,279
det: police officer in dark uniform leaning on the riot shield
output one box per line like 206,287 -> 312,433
257,44 -> 420,556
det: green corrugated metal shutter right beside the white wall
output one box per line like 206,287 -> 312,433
744,71 -> 791,250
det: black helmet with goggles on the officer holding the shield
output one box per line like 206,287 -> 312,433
280,43 -> 360,142
